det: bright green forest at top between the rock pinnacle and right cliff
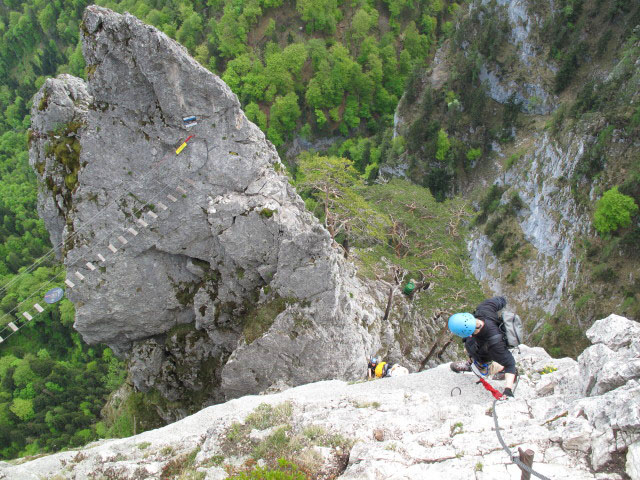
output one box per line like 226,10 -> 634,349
92,0 -> 458,146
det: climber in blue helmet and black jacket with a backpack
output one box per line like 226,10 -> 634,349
448,297 -> 516,397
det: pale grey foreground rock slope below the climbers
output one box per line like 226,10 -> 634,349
0,316 -> 640,480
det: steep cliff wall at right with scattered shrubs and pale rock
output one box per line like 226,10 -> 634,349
390,0 -> 640,355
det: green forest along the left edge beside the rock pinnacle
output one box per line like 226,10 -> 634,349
0,0 -> 116,459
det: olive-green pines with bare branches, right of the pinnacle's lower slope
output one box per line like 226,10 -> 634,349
354,179 -> 483,316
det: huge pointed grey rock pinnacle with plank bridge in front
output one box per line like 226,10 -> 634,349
30,6 -> 390,403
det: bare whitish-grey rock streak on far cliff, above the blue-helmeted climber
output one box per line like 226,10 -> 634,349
469,134 -> 591,313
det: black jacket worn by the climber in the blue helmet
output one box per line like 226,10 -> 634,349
465,297 -> 516,374
